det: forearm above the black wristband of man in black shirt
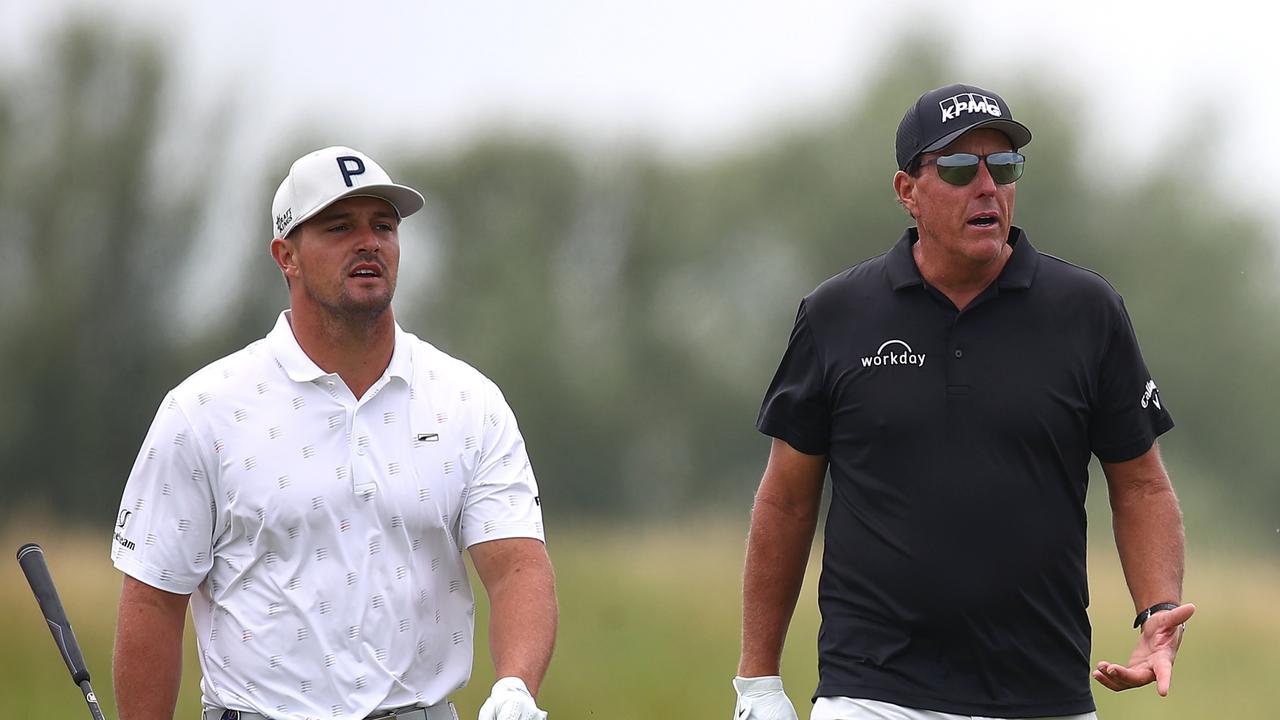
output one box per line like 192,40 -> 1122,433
1111,479 -> 1184,611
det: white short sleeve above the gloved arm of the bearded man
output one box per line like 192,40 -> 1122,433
461,380 -> 544,547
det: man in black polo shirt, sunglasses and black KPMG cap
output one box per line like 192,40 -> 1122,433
733,85 -> 1196,720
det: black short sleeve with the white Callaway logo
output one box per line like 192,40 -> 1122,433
1089,296 -> 1174,462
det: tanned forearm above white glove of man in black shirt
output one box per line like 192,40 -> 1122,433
737,488 -> 818,678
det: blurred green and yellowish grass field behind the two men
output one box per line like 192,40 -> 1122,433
0,518 -> 1280,720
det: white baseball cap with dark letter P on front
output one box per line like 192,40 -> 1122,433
271,145 -> 426,237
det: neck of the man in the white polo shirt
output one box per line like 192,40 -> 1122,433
289,304 -> 396,400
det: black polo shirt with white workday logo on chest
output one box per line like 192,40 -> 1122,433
756,227 -> 1172,716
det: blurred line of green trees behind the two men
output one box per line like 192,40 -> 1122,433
0,23 -> 1280,537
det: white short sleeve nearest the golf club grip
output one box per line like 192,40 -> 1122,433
111,393 -> 214,594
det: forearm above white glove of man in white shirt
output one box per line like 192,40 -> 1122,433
485,541 -> 558,696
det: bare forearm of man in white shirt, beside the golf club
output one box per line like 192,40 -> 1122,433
113,578 -> 187,720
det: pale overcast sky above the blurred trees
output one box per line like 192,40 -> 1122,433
0,0 -> 1280,227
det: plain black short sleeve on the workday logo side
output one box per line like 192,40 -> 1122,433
755,302 -> 831,455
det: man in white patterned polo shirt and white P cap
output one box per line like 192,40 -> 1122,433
111,147 -> 557,720
